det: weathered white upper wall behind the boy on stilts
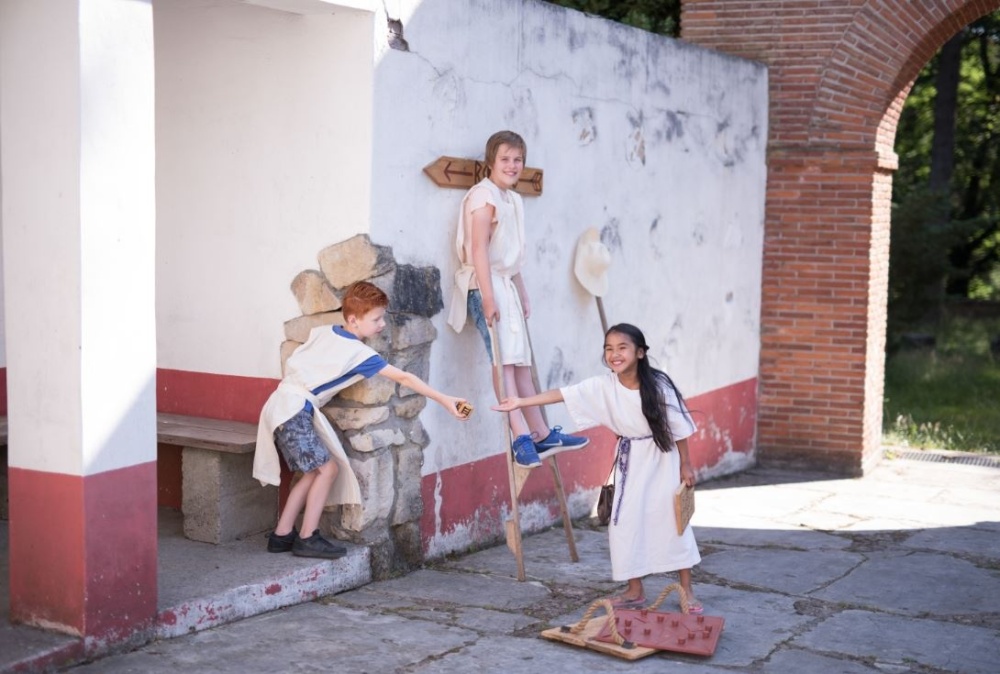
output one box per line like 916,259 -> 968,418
371,0 -> 767,475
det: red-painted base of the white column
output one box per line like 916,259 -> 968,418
8,462 -> 157,639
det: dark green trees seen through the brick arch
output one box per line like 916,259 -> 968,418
890,12 -> 1000,314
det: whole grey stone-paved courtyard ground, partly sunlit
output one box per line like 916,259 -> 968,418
9,461 -> 1000,674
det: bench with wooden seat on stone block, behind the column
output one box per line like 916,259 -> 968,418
0,413 -> 278,543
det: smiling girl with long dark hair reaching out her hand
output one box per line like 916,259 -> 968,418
493,323 -> 702,613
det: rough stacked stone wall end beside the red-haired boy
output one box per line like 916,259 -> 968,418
281,234 -> 444,579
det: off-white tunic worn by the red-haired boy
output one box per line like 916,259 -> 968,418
253,325 -> 381,506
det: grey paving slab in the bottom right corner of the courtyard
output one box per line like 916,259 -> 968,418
792,611 -> 1000,674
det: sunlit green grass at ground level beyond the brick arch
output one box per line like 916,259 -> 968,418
882,318 -> 1000,453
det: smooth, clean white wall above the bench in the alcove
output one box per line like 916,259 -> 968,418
154,0 -> 373,378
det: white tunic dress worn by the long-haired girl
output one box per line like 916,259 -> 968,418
560,372 -> 701,580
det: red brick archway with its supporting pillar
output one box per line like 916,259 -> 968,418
681,0 -> 1000,475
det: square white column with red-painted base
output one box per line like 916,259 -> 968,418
0,0 -> 156,635
